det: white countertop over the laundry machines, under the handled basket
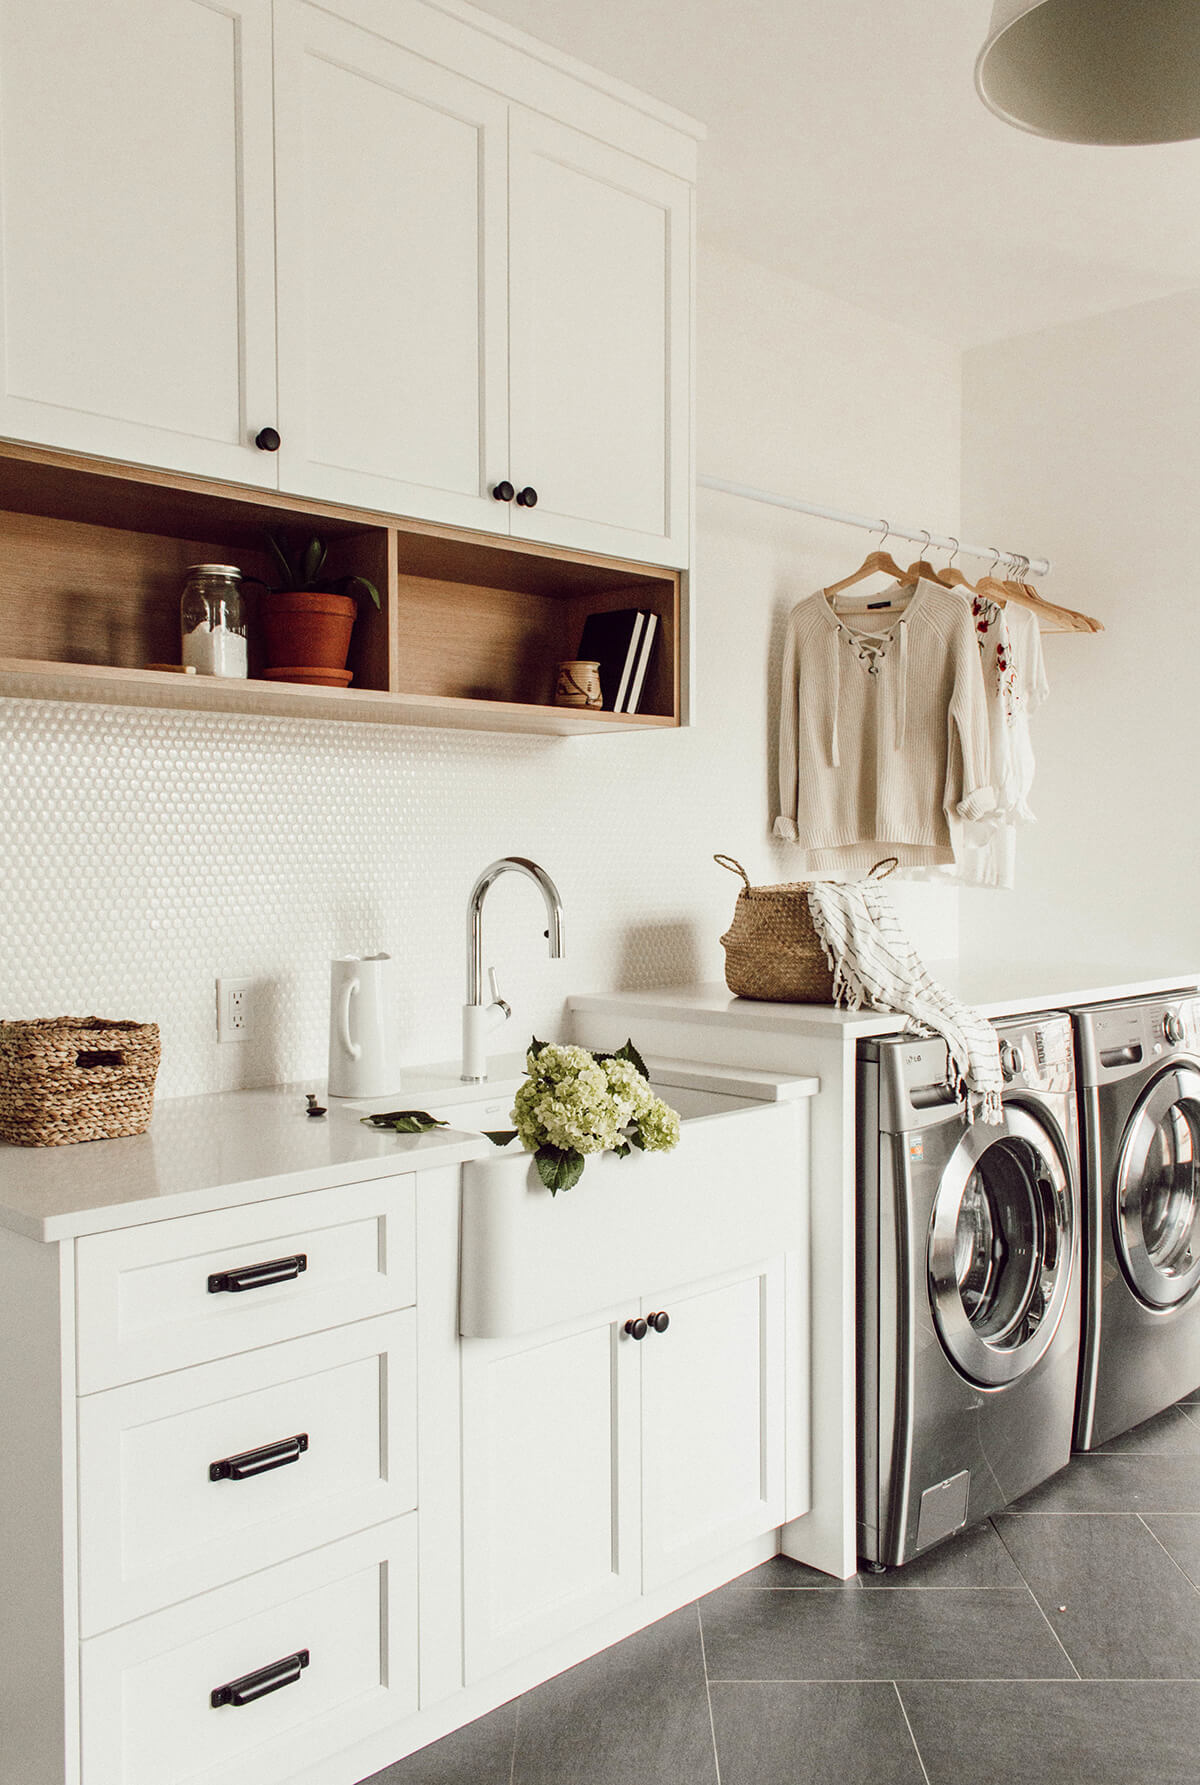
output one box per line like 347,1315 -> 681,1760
568,960 -> 1200,1039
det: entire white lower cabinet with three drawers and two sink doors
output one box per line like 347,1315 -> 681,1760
0,1117 -> 807,1785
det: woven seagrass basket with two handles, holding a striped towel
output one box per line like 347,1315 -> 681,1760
713,855 -> 896,1005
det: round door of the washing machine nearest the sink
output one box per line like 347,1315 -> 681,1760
929,1105 -> 1075,1387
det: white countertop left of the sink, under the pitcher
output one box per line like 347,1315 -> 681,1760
0,1076 -> 491,1241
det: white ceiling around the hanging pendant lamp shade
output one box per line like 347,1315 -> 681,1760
482,0 -> 1200,346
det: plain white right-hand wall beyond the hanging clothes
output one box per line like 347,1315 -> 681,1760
961,293 -> 1200,971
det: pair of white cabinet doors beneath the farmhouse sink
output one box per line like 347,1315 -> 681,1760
463,1258 -> 786,1683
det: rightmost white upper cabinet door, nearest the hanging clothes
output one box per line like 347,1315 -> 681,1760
509,107 -> 691,566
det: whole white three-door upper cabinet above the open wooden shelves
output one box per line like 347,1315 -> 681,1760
0,0 -> 696,566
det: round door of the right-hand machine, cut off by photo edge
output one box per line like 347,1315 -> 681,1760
1113,1066 -> 1200,1308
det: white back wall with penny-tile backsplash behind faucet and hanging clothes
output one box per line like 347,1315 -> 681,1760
0,253 -> 959,1094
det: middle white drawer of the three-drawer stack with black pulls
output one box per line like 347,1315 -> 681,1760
79,1308 -> 416,1635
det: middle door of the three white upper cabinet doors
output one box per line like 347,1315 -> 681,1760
275,0 -> 507,532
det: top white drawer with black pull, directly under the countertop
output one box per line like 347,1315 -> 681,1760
77,1175 -> 414,1394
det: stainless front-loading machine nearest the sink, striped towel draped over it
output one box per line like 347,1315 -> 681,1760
857,1014 -> 1080,1565
